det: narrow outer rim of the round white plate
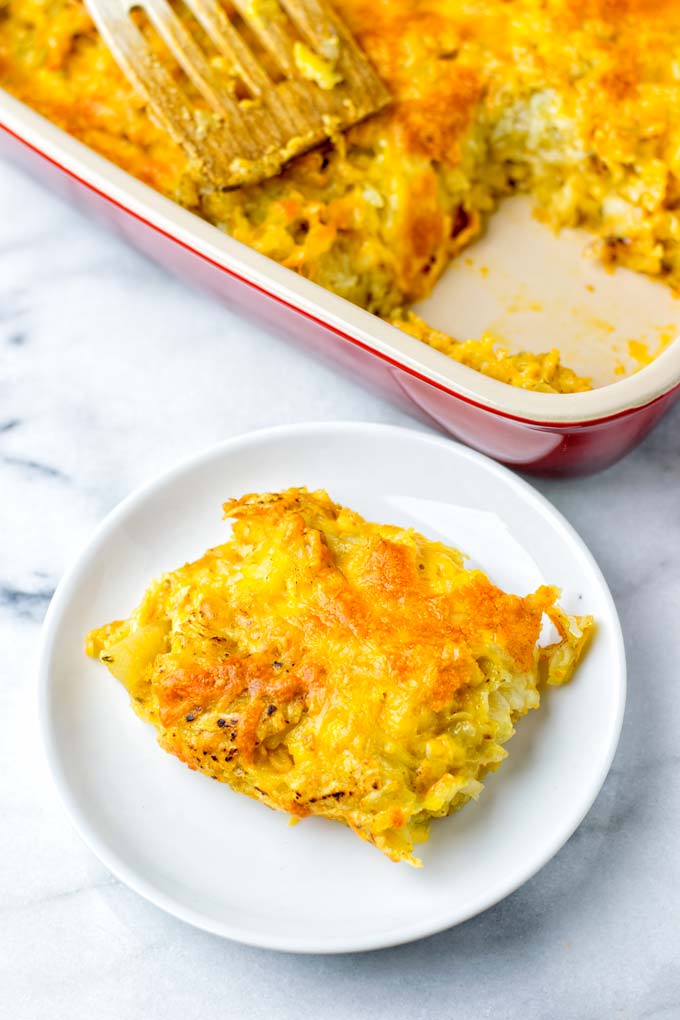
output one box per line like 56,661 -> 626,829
38,420 -> 627,956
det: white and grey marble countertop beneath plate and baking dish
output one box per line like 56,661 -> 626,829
0,153 -> 680,1020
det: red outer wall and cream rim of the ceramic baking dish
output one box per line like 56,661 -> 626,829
0,90 -> 680,475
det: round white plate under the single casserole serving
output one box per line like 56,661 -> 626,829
41,423 -> 625,953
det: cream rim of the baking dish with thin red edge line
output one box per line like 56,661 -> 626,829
5,89 -> 680,425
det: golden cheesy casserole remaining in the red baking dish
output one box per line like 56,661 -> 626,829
0,0 -> 680,393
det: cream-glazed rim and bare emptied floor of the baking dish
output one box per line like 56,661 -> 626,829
0,90 -> 680,423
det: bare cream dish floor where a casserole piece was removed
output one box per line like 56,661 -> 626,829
414,196 -> 680,387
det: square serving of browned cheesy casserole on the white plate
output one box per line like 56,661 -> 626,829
88,489 -> 591,863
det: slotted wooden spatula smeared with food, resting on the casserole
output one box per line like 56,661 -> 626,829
86,0 -> 389,188
